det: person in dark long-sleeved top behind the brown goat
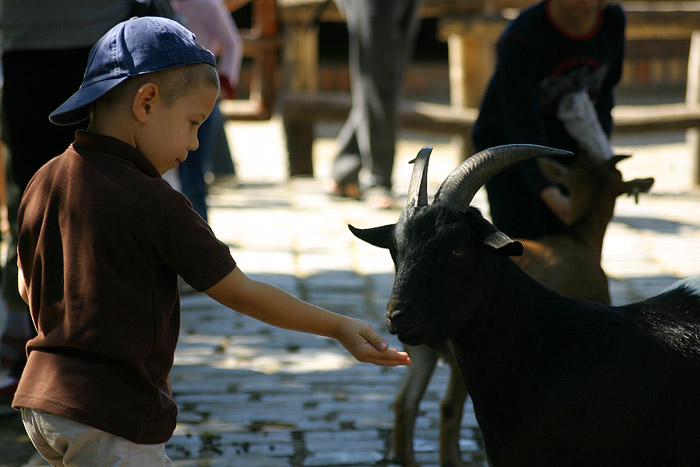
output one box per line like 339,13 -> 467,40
473,0 -> 625,239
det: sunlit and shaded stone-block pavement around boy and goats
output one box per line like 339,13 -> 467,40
0,119 -> 700,467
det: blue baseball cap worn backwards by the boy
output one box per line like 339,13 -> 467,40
49,16 -> 216,125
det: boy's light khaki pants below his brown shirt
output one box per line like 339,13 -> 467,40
22,407 -> 173,467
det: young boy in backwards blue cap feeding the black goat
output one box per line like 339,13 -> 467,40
13,17 -> 409,466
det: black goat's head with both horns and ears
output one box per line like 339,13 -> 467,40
349,144 -> 571,347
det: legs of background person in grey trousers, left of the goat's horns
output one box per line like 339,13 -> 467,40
328,0 -> 421,209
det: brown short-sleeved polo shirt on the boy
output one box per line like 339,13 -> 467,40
13,132 -> 235,444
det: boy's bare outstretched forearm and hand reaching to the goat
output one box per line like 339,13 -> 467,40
205,268 -> 410,366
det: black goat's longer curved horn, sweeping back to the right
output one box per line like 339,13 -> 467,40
435,144 -> 573,211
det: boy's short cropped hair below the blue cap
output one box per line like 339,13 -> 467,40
90,63 -> 219,118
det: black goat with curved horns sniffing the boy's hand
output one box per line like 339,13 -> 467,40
351,145 -> 700,466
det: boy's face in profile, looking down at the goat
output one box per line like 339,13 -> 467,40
138,86 -> 218,175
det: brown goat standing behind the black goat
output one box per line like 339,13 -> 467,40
392,156 -> 654,467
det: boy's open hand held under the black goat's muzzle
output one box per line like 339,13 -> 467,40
337,318 -> 411,366
